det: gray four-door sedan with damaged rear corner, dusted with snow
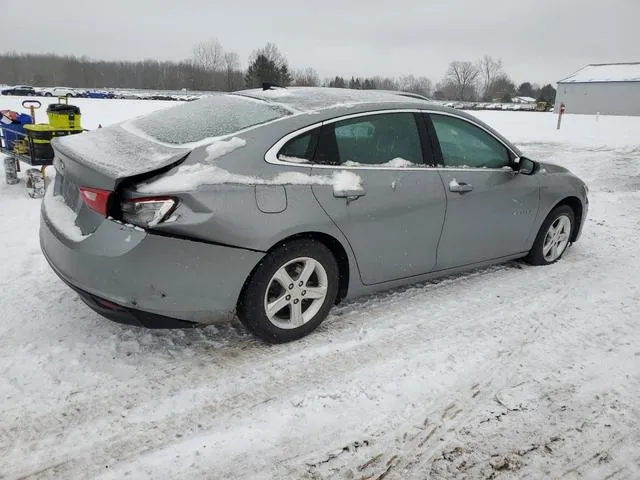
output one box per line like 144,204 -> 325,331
40,87 -> 588,342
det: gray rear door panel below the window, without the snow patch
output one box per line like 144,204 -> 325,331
312,167 -> 446,285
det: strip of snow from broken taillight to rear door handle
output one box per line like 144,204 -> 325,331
138,163 -> 362,194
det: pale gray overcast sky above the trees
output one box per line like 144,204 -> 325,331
0,0 -> 640,83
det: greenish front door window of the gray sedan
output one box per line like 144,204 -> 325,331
431,114 -> 511,168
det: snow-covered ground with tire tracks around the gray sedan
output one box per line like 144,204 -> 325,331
0,99 -> 640,480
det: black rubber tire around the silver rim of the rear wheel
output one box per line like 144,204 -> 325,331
238,239 -> 339,343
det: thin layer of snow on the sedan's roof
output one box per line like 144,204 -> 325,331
234,87 -> 425,112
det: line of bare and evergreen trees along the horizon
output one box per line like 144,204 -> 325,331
0,38 -> 555,102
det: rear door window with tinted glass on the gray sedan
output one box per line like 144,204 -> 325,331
317,113 -> 423,167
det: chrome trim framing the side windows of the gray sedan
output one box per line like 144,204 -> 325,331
264,108 -> 520,172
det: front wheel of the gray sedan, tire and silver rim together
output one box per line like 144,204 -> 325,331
525,205 -> 576,265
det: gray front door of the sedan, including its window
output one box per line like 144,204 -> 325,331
426,113 -> 540,269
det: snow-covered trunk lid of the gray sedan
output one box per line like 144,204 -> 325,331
52,124 -> 191,178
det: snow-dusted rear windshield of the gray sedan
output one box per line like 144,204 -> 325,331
132,95 -> 290,145
